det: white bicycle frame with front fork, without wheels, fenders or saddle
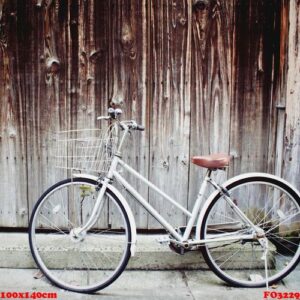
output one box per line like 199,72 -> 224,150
76,122 -> 258,246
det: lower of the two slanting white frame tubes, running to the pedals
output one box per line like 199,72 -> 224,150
113,171 -> 183,242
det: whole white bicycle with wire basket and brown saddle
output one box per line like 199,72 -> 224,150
29,108 -> 300,293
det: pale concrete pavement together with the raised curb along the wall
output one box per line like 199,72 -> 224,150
0,233 -> 300,300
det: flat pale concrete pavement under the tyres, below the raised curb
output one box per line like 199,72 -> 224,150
0,267 -> 300,300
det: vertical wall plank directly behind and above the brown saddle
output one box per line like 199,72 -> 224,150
189,1 -> 234,208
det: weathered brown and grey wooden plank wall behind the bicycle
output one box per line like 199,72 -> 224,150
0,0 -> 300,228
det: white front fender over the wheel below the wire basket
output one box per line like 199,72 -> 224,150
72,174 -> 137,256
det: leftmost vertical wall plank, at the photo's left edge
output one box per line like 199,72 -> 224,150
0,1 -> 28,227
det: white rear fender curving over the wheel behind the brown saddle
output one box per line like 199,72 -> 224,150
195,172 -> 300,239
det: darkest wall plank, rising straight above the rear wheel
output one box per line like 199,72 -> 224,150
230,1 -> 280,175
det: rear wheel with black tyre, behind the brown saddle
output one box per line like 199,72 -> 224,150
200,174 -> 300,287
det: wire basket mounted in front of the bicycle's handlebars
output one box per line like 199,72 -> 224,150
54,126 -> 118,174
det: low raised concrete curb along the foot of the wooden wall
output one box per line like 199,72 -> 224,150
0,233 -> 274,270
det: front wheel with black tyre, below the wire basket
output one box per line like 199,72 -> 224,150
29,178 -> 131,293
